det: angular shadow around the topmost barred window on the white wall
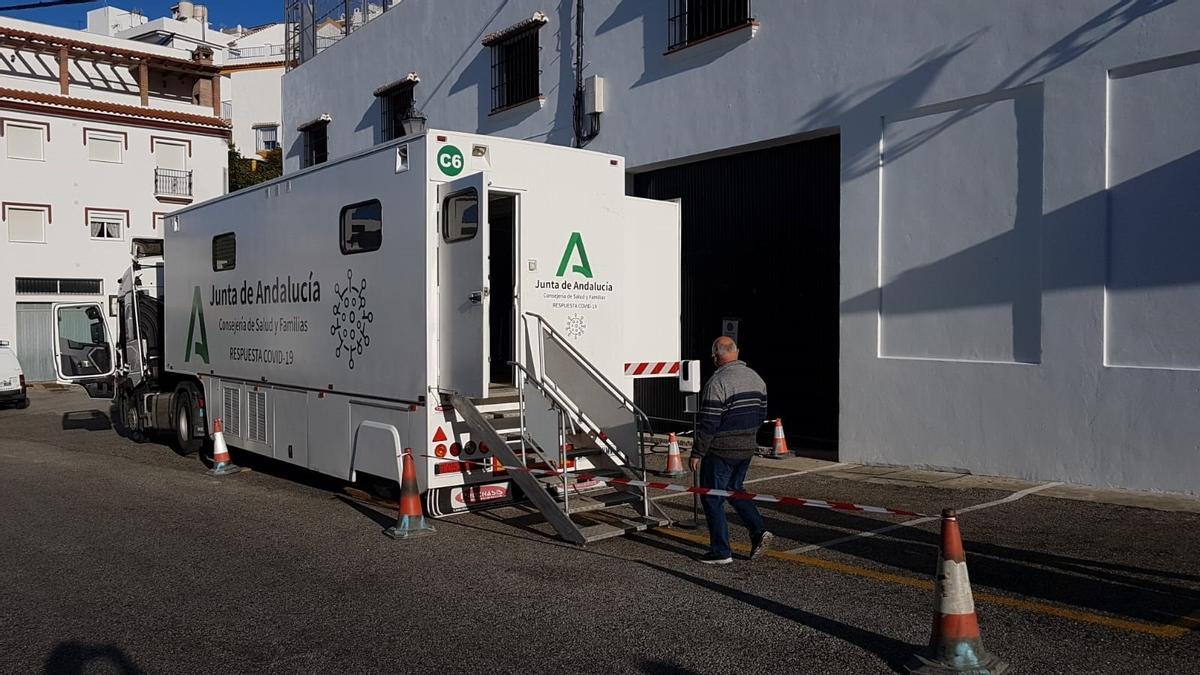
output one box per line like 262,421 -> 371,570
596,0 -> 750,89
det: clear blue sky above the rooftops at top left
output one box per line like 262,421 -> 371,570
0,0 -> 283,30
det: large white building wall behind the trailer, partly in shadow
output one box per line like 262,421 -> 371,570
283,0 -> 1200,492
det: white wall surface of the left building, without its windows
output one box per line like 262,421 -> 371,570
0,19 -> 228,379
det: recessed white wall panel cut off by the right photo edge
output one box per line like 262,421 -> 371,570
1105,52 -> 1200,370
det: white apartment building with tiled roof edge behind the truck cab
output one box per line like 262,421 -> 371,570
0,18 -> 230,381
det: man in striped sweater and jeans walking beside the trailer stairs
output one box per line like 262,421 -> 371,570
689,338 -> 774,565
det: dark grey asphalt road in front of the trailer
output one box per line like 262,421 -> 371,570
0,390 -> 1200,674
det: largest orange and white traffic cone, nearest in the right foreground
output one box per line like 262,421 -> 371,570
905,508 -> 1008,675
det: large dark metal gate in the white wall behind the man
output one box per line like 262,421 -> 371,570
634,135 -> 841,449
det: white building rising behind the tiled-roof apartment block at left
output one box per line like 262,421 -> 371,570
88,2 -> 284,157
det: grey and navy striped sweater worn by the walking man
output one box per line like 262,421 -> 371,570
691,362 -> 767,460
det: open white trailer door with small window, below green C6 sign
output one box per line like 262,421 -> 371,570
438,173 -> 491,399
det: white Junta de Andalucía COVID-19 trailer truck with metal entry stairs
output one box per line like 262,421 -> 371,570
55,131 -> 680,543
